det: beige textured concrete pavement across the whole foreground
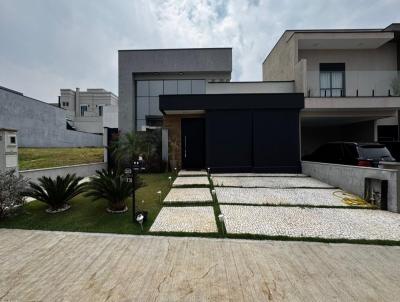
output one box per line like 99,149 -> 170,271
0,229 -> 400,301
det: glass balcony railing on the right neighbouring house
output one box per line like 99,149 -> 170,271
306,70 -> 400,97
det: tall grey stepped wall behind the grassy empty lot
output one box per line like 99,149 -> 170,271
0,88 -> 102,147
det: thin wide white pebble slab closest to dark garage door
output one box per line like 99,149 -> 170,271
212,176 -> 333,188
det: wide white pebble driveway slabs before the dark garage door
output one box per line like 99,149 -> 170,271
213,174 -> 400,241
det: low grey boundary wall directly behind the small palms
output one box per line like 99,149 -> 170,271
19,163 -> 107,182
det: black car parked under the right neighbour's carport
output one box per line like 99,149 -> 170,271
302,142 -> 396,167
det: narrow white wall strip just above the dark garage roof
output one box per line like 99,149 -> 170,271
206,81 -> 294,94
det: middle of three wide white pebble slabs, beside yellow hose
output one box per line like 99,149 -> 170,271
215,187 -> 364,207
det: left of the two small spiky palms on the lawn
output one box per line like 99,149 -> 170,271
24,174 -> 85,212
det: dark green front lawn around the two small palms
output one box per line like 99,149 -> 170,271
0,173 -> 172,234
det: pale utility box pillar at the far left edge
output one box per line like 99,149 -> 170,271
0,128 -> 18,172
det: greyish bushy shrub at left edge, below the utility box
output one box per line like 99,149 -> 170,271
0,170 -> 27,219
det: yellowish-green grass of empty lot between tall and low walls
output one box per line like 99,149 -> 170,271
18,148 -> 103,170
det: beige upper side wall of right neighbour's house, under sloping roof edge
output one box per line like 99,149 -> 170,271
262,31 -> 297,81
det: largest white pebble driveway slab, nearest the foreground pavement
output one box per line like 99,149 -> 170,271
220,205 -> 400,240
